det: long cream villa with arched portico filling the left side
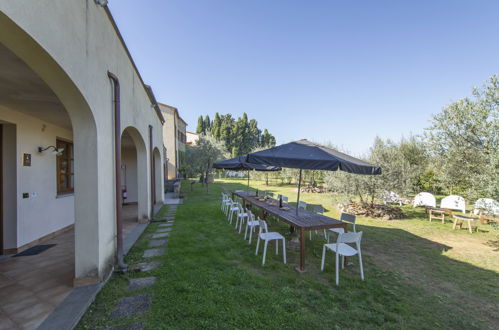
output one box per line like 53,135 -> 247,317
0,0 -> 168,328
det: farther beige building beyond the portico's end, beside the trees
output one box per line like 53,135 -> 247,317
158,103 -> 187,180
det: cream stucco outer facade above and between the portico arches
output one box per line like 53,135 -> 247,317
0,0 -> 163,278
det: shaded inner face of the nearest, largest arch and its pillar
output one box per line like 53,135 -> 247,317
0,13 -> 102,279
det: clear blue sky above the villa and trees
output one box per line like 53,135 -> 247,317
109,0 -> 499,155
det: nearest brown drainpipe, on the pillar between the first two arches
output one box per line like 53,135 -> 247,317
107,71 -> 128,271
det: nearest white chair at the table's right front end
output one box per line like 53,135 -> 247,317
321,232 -> 364,285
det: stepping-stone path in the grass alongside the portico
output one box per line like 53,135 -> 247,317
111,205 -> 177,330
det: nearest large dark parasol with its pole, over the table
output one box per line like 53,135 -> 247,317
246,139 -> 381,214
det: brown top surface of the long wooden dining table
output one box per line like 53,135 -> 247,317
234,191 -> 345,230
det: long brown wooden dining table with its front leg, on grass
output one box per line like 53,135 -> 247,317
232,191 -> 348,272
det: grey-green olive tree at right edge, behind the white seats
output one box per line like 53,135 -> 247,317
426,75 -> 499,199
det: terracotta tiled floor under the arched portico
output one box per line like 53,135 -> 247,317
0,204 -> 141,330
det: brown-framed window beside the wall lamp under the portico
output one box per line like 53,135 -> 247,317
57,140 -> 74,195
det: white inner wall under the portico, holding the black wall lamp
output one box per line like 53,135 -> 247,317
0,106 -> 74,249
